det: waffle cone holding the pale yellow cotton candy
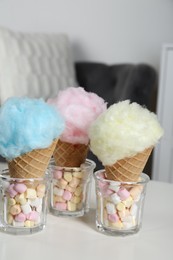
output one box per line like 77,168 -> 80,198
105,147 -> 153,182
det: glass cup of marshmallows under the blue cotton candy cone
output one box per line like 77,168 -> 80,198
0,169 -> 49,235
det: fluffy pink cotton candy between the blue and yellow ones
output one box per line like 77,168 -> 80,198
48,87 -> 107,144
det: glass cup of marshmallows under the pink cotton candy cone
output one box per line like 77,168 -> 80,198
49,159 -> 96,217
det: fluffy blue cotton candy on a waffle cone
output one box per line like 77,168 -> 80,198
0,97 -> 65,160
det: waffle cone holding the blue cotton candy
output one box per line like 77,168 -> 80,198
8,140 -> 57,179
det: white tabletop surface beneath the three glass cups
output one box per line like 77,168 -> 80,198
0,162 -> 173,260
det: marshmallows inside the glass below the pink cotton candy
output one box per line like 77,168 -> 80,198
51,167 -> 88,212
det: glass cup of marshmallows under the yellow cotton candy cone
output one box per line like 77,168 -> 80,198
94,170 -> 150,236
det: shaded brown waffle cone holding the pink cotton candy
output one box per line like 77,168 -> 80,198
53,140 -> 88,167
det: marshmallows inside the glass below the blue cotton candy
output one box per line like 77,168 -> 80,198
5,182 -> 46,227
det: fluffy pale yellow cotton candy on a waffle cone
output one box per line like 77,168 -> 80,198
89,100 -> 163,165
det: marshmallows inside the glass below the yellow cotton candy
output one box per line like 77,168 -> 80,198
97,176 -> 143,230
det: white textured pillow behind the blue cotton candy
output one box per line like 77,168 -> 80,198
0,28 -> 77,104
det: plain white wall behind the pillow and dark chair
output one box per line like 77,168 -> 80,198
0,0 -> 173,69
